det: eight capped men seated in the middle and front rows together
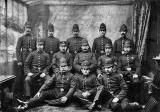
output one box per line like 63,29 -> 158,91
15,39 -> 143,110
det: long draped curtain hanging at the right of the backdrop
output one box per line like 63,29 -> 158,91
133,1 -> 151,61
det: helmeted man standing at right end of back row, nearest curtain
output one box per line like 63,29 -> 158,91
113,24 -> 135,57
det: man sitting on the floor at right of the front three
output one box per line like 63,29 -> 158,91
98,58 -> 141,111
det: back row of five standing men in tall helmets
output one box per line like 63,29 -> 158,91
16,22 -> 135,65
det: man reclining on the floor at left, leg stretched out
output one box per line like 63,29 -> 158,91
18,58 -> 76,110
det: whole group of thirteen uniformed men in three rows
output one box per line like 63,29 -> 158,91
16,23 -> 156,111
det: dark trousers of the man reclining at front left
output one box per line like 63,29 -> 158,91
28,89 -> 63,107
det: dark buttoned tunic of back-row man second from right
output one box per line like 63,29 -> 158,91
92,36 -> 112,59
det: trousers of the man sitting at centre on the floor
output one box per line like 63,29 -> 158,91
73,86 -> 102,108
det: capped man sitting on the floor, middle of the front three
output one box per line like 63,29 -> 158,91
74,60 -> 100,110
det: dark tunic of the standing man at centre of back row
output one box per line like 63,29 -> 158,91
67,37 -> 84,60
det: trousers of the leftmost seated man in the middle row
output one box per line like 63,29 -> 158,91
24,75 -> 48,97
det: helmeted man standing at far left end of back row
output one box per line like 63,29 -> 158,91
14,22 -> 37,96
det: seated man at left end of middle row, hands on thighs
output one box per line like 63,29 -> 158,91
24,40 -> 50,99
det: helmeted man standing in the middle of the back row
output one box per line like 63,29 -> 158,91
67,24 -> 83,60
